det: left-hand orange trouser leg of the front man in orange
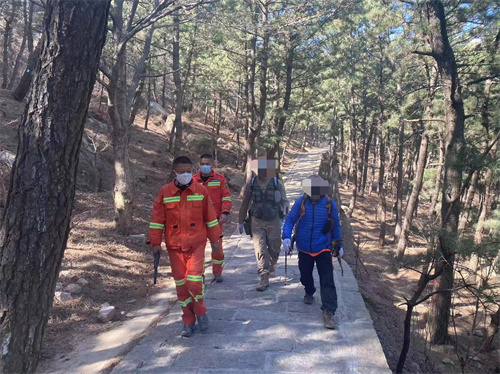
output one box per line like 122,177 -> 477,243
168,249 -> 196,325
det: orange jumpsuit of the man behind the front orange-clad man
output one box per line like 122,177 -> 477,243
194,170 -> 233,275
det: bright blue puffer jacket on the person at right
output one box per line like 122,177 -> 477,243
282,195 -> 342,253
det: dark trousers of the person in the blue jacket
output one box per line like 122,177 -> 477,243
299,251 -> 338,314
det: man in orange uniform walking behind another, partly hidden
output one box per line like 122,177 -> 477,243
194,153 -> 233,283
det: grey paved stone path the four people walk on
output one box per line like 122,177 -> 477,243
112,150 -> 390,374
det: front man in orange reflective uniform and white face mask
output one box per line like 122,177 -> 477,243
149,156 -> 222,337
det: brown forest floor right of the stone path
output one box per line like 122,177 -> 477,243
339,185 -> 500,373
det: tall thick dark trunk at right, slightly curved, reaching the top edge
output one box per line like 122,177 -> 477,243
425,0 -> 465,344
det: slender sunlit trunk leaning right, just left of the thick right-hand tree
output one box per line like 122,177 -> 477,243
397,134 -> 429,262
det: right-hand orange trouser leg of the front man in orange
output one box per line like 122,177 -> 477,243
186,244 -> 207,316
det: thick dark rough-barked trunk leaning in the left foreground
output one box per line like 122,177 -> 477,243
0,0 -> 109,373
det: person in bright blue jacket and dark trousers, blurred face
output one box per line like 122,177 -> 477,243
282,176 -> 343,329
